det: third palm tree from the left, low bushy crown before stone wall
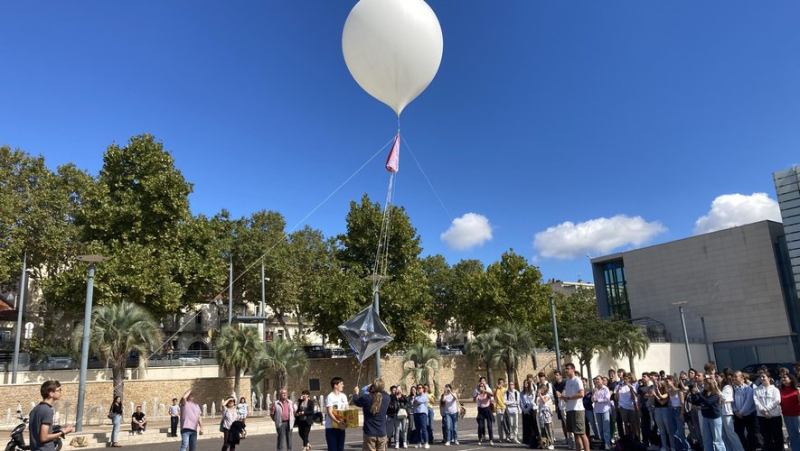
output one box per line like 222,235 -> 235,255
253,340 -> 308,389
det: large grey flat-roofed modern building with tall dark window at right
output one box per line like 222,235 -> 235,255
591,221 -> 800,369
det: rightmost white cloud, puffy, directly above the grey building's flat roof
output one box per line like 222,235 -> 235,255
694,193 -> 781,235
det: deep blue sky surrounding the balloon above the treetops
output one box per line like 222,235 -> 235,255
0,0 -> 800,280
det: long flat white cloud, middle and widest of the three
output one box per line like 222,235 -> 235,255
533,215 -> 667,259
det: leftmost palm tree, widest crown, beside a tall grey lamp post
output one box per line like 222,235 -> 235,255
72,301 -> 163,398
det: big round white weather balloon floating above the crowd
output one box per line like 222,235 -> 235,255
342,0 -> 443,116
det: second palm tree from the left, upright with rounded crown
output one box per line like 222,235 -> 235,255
214,325 -> 263,396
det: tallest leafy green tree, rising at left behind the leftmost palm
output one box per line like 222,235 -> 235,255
47,135 -> 226,315
